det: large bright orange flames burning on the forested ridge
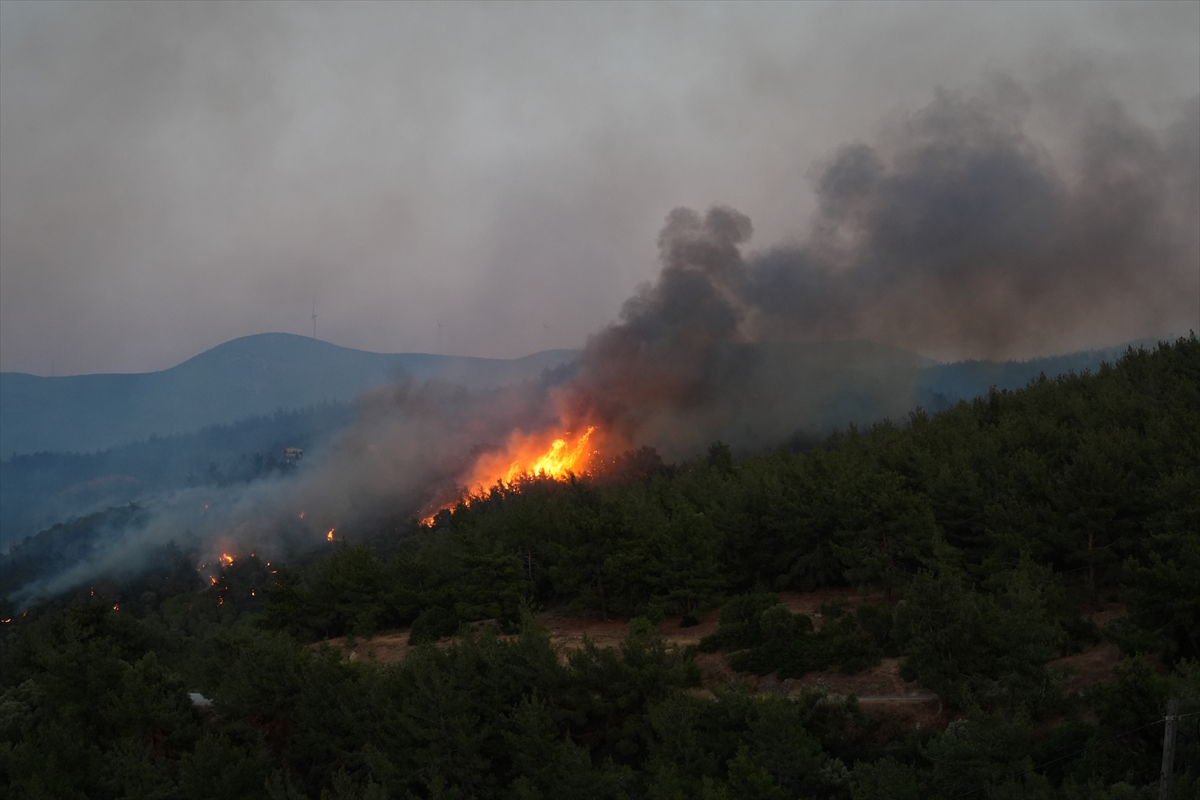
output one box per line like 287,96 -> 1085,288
421,427 -> 595,525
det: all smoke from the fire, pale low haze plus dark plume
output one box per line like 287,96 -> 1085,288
11,80 -> 1200,604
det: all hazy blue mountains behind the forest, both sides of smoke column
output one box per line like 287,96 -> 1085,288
0,333 -> 1153,553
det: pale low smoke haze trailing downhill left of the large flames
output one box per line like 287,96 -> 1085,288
13,381 -> 548,604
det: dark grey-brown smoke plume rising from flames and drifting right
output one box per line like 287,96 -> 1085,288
560,79 -> 1200,455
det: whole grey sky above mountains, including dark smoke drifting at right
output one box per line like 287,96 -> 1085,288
0,0 -> 1200,374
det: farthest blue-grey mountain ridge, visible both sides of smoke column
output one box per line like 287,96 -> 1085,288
0,333 -> 1153,458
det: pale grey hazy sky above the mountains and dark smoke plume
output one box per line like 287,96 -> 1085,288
0,1 -> 1200,374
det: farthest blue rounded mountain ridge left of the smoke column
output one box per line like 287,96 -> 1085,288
0,333 -> 577,458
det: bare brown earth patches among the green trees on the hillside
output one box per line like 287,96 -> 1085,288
324,589 -> 1124,728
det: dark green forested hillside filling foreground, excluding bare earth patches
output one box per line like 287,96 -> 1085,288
0,336 -> 1200,800
